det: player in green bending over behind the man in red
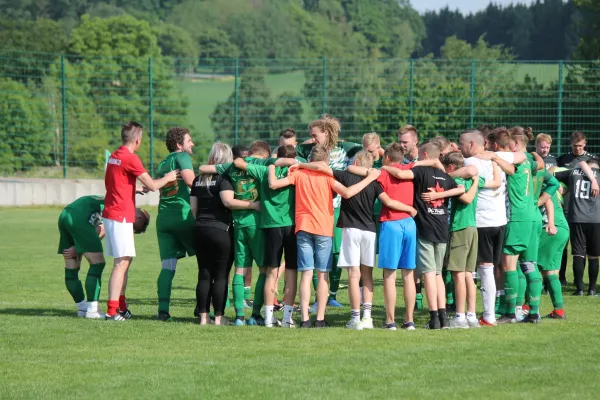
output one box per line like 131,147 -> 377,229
58,196 -> 150,319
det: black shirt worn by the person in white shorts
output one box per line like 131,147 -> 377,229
333,170 -> 383,232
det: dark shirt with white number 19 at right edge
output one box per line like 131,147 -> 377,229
555,168 -> 600,223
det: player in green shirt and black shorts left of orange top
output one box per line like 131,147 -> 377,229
235,145 -> 298,328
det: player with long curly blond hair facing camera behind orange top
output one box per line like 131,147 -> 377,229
296,114 -> 362,311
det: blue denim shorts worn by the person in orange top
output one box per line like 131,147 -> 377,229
296,231 -> 333,272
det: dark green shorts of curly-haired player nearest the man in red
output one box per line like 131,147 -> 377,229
156,213 -> 196,260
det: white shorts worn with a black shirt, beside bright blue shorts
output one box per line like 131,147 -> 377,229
338,228 -> 377,268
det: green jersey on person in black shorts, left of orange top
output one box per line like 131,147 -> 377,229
246,164 -> 296,228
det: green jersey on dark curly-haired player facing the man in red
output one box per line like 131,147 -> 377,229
156,151 -> 194,220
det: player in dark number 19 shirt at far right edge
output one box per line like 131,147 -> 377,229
555,158 -> 600,296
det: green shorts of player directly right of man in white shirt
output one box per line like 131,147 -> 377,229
502,221 -> 542,262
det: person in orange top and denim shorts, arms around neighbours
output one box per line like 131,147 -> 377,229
269,145 -> 379,328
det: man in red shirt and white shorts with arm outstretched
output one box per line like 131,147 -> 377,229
102,121 -> 177,321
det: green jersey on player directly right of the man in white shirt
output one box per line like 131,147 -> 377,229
506,158 -> 541,222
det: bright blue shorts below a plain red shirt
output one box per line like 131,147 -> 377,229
379,218 -> 417,269
